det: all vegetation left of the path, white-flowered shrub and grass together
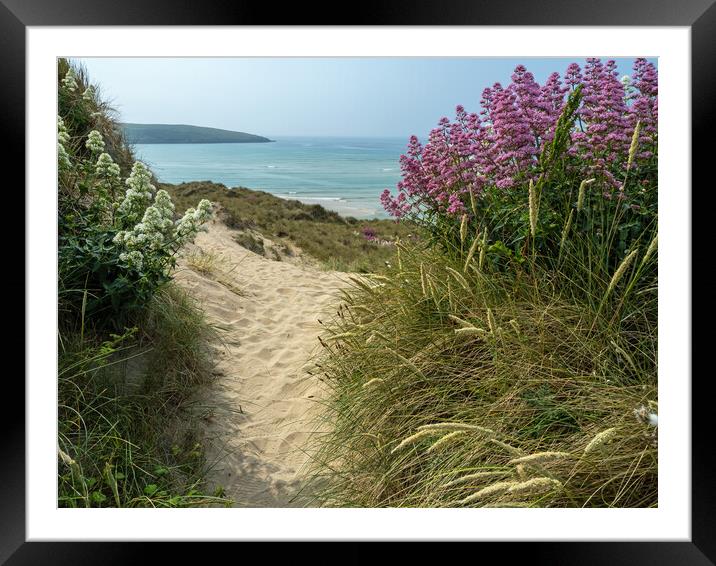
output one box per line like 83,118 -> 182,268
58,59 -> 230,507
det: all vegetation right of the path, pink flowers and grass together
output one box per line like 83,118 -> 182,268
308,59 -> 658,507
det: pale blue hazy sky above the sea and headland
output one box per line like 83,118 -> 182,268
76,57 -> 657,138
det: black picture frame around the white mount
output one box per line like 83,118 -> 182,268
5,0 -> 716,566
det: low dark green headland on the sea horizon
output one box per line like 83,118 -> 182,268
121,123 -> 273,144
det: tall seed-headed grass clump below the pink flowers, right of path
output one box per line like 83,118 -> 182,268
304,235 -> 657,507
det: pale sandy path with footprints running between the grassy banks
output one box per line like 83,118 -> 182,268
176,221 -> 345,507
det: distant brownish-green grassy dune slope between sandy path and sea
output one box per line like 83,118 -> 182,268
161,181 -> 417,272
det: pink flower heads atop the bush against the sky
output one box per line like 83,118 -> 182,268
381,58 -> 658,218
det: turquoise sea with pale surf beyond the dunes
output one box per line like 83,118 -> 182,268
134,136 -> 408,218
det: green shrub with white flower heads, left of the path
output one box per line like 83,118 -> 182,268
58,64 -> 211,328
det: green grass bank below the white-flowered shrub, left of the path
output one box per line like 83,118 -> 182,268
58,285 -> 229,507
